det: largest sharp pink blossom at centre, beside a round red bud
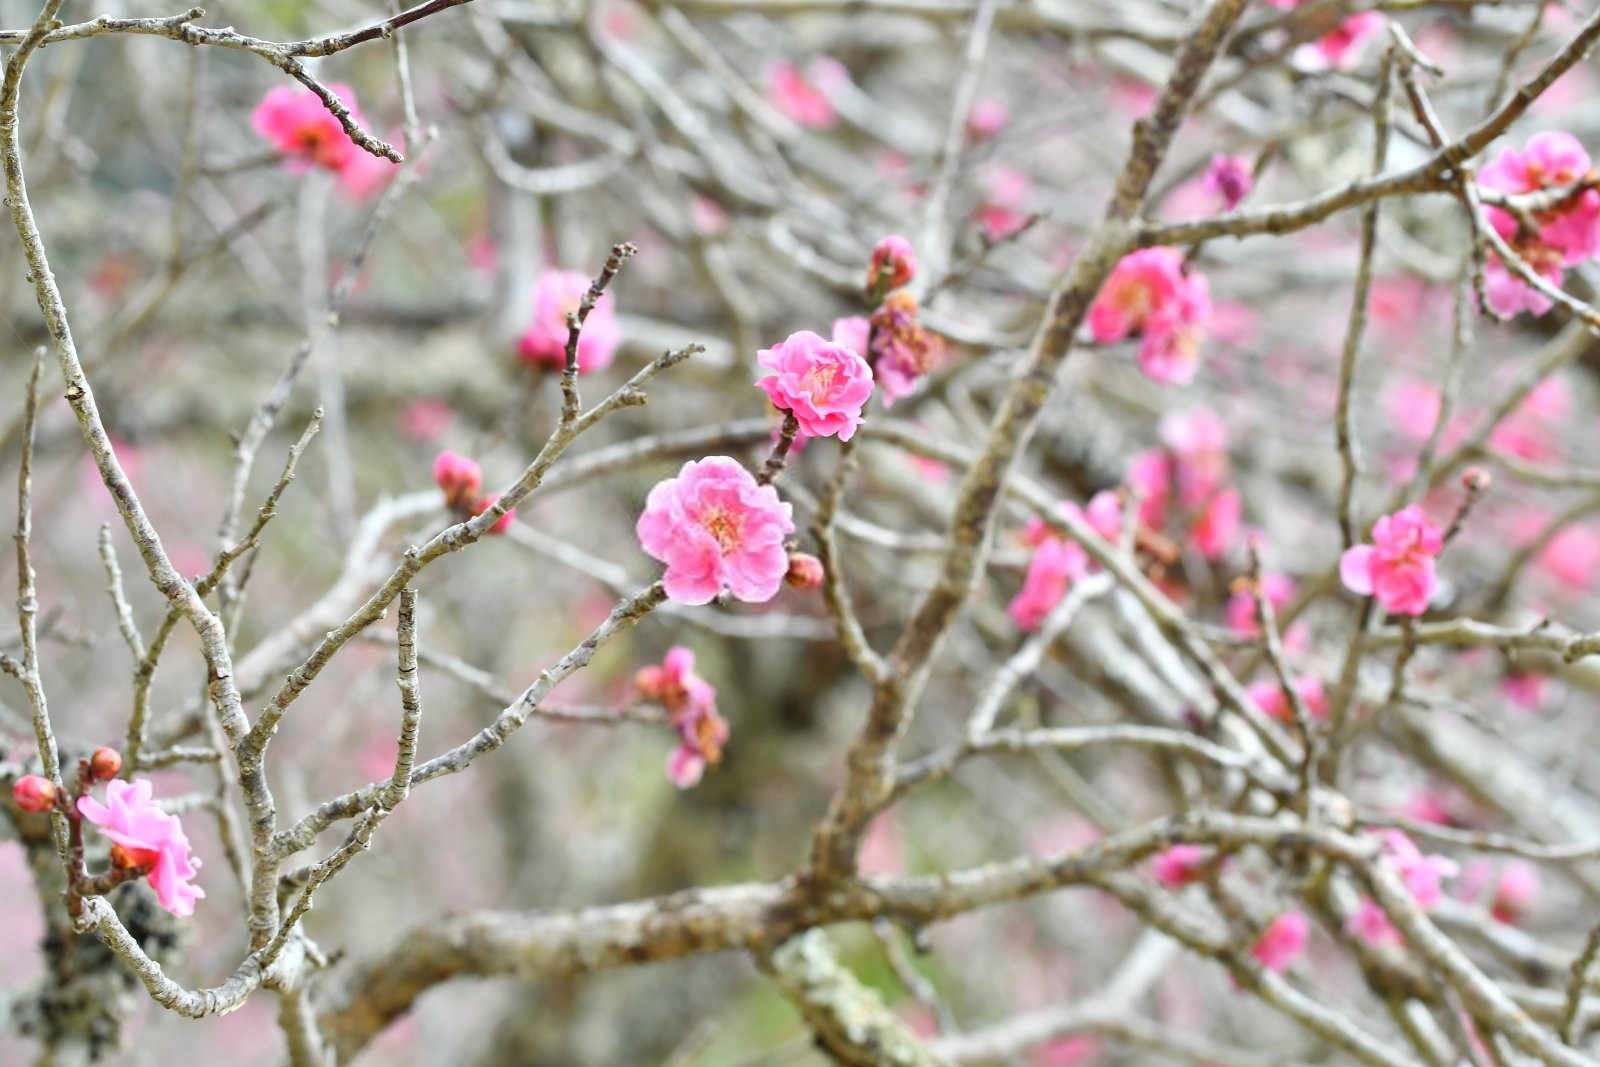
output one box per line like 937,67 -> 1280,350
637,456 -> 795,605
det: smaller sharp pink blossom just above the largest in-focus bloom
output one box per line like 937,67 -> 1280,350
755,330 -> 872,442
